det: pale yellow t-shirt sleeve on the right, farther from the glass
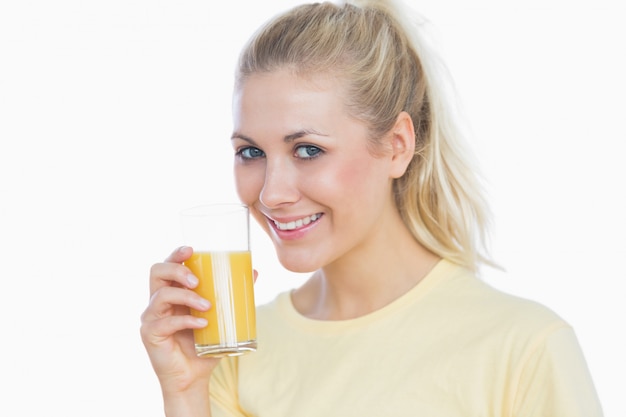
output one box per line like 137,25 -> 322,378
514,325 -> 603,417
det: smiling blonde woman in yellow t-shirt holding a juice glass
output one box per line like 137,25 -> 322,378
142,1 -> 601,417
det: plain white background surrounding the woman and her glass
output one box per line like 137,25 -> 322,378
0,0 -> 626,416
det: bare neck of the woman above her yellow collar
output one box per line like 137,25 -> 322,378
292,208 -> 439,320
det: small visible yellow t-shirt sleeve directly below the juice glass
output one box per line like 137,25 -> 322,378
209,357 -> 248,417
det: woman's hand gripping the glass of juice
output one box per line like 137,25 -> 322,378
141,247 -> 219,396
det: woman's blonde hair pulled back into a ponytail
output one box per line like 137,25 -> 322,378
236,0 -> 492,271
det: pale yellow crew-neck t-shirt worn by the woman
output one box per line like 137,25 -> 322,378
210,260 -> 602,417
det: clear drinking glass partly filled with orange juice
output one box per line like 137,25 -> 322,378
182,204 -> 256,356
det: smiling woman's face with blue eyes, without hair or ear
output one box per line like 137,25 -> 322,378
232,71 -> 395,272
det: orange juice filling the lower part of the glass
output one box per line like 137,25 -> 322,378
185,251 -> 256,356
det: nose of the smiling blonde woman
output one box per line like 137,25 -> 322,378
259,160 -> 300,209
